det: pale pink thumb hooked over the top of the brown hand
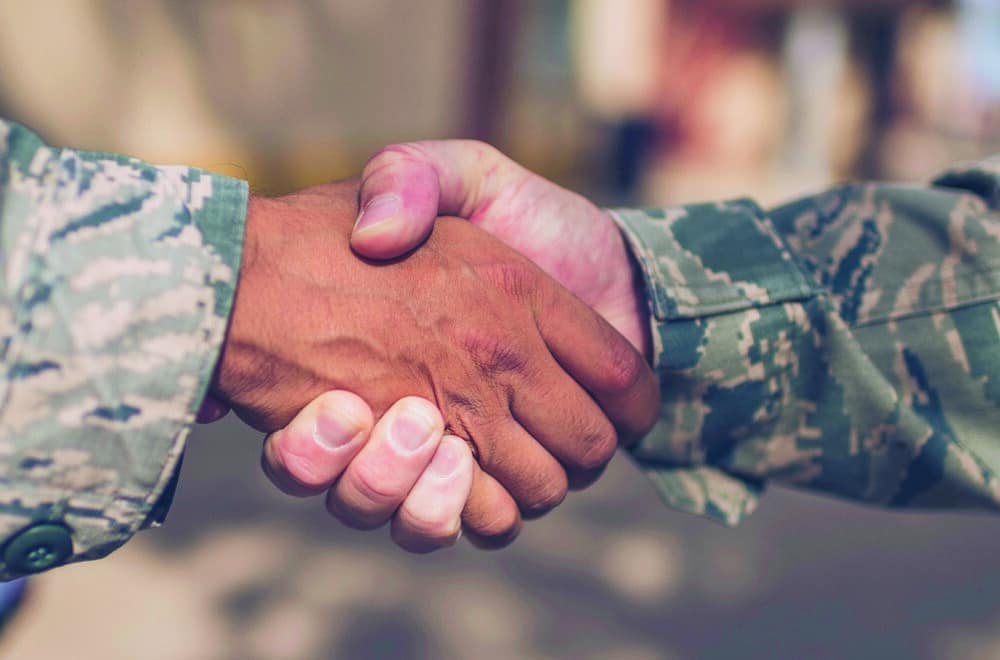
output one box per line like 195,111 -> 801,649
351,140 -> 520,259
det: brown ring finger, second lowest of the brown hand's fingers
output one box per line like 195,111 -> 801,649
470,418 -> 569,518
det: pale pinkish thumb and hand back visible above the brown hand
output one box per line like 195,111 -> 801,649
351,140 -> 651,359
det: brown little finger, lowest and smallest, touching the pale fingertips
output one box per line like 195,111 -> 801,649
462,466 -> 521,550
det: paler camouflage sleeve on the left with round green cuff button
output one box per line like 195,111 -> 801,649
0,121 -> 247,579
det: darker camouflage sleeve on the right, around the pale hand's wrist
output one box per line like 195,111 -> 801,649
613,158 -> 1000,524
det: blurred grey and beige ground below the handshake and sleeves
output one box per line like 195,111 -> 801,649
0,422 -> 1000,660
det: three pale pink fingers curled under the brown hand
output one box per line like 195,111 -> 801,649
261,391 -> 475,553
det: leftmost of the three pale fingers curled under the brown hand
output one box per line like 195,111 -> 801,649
261,390 -> 372,497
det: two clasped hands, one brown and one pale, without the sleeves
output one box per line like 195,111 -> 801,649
200,141 -> 659,552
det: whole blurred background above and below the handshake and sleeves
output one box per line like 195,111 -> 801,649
0,0 -> 1000,660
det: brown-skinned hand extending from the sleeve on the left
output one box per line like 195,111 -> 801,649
212,179 -> 658,544
